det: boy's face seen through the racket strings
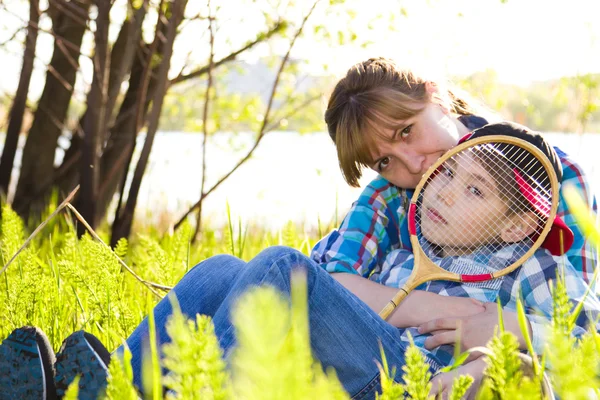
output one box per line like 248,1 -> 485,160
421,151 -> 507,255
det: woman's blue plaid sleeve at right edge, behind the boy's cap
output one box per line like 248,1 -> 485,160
554,147 -> 598,284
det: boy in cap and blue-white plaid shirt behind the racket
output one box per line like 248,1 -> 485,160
370,123 -> 600,365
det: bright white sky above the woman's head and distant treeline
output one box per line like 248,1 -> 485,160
296,0 -> 600,85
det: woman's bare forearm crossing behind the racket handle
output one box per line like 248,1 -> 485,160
331,273 -> 484,328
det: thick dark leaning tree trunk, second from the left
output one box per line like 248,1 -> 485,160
13,0 -> 90,219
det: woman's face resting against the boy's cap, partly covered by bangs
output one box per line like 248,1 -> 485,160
371,102 -> 468,189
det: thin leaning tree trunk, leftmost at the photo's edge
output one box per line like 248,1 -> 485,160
0,0 -> 40,195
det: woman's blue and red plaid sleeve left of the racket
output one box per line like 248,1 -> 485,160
311,177 -> 410,277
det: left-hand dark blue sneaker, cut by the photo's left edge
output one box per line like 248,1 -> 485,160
0,326 -> 58,400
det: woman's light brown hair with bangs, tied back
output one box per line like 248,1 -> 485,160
325,57 -> 473,187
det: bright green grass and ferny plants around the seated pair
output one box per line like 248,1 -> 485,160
0,185 -> 600,399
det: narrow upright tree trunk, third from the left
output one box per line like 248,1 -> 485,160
77,0 -> 112,235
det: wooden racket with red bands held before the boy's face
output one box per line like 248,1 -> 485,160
379,132 -> 572,319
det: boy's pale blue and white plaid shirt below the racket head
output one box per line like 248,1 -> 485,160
370,244 -> 600,365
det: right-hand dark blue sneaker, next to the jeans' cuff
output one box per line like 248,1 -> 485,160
54,331 -> 110,400
